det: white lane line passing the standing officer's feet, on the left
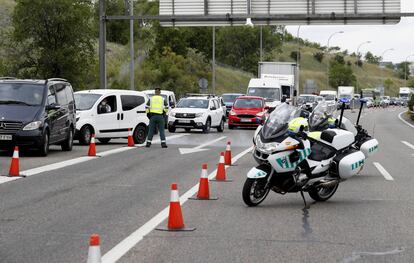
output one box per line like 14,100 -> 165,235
0,134 -> 189,184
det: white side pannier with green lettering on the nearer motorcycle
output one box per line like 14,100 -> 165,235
331,150 -> 365,179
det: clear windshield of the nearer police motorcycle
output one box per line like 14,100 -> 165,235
262,103 -> 300,139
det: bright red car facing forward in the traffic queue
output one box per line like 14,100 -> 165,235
228,96 -> 268,129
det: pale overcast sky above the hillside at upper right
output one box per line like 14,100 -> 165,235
286,0 -> 414,63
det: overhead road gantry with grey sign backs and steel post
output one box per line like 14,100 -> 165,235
99,0 -> 406,88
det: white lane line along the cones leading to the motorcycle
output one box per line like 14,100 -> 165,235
102,147 -> 252,263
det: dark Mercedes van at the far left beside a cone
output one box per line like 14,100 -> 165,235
0,78 -> 76,156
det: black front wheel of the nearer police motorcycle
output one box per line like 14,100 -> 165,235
242,178 -> 270,206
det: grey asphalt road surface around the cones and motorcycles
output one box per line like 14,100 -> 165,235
0,108 -> 414,262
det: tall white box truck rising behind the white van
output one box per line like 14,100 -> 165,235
258,62 -> 299,99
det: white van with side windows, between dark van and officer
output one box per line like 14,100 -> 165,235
75,89 -> 149,144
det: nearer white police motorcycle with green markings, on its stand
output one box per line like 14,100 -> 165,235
242,103 -> 366,206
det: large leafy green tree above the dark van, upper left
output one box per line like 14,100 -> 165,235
12,0 -> 95,88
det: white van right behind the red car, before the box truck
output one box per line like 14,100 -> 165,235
247,78 -> 282,108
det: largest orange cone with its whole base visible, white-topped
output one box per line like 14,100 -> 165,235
157,183 -> 195,231
